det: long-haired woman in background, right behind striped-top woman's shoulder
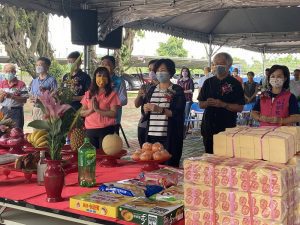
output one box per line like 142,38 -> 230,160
177,67 -> 194,135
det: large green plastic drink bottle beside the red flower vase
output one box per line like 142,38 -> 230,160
78,138 -> 96,187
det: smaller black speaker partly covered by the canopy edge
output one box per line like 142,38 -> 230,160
99,27 -> 123,49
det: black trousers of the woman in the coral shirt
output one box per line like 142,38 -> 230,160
86,125 -> 115,149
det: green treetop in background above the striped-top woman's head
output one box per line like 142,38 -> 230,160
156,37 -> 188,57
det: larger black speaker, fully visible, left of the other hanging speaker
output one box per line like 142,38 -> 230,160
70,10 -> 98,45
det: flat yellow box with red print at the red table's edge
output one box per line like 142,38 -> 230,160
70,190 -> 135,218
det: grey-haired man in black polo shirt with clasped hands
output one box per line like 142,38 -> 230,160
198,52 -> 245,153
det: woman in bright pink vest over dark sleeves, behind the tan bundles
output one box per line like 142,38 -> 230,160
251,65 -> 299,126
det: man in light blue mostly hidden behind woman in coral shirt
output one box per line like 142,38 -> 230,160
101,55 -> 127,134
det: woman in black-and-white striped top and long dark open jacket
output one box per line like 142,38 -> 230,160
144,59 -> 186,167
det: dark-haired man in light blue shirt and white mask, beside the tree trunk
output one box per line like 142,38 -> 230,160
29,57 -> 57,120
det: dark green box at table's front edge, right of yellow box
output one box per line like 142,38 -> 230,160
118,198 -> 184,225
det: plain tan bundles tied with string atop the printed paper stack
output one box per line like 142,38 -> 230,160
214,127 -> 299,163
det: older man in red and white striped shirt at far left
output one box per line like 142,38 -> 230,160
0,64 -> 28,129
